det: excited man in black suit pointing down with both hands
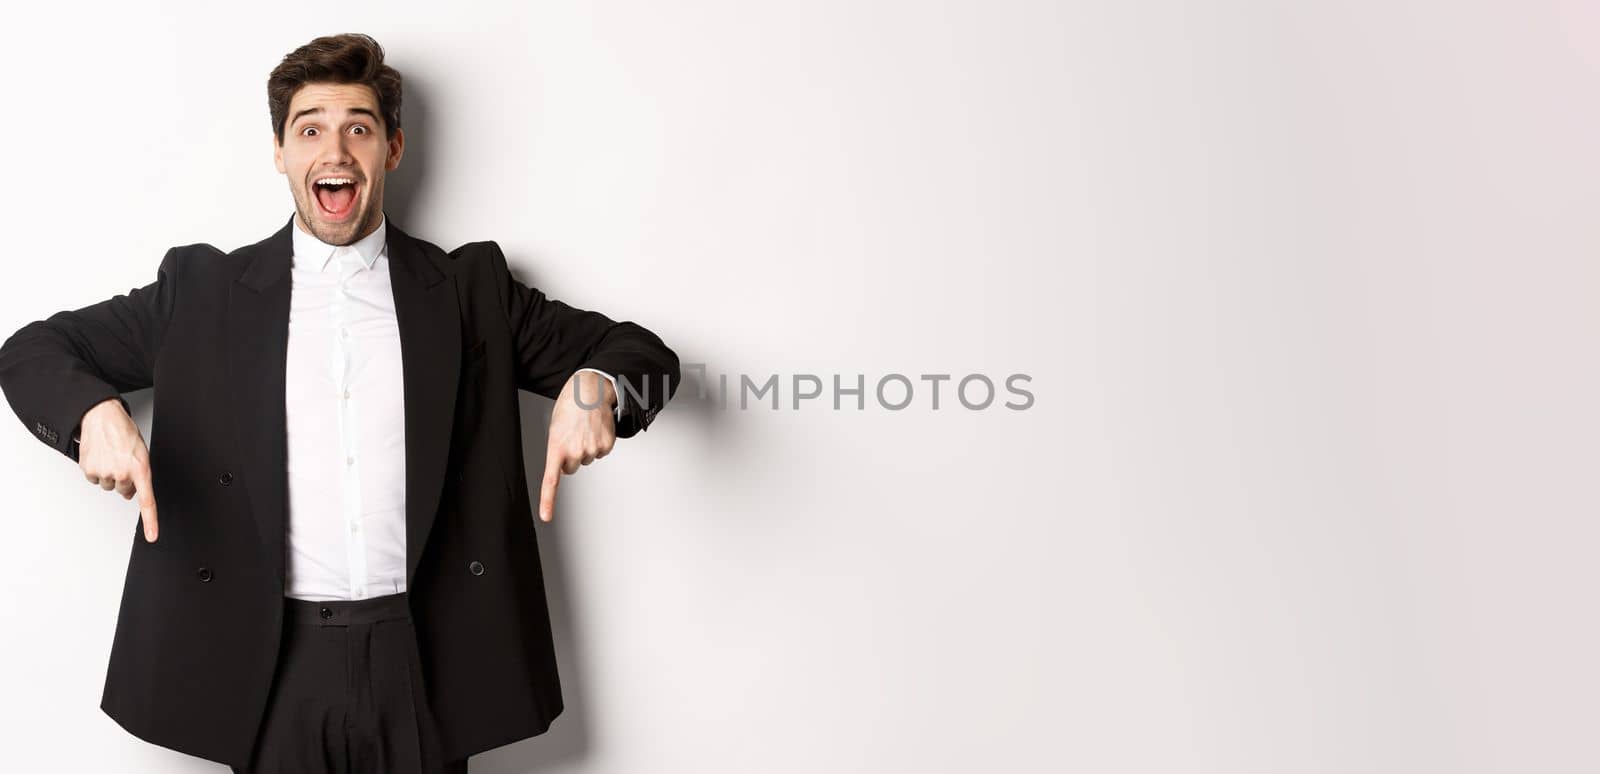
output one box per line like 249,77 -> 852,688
0,35 -> 678,774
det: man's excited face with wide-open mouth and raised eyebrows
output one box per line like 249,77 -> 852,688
272,83 -> 405,245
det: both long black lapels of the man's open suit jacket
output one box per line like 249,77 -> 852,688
224,216 -> 461,592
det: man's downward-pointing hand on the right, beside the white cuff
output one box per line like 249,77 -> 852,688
539,371 -> 616,521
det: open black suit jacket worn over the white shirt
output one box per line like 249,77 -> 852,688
0,217 -> 678,766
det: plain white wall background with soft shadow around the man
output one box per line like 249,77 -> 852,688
0,0 -> 1600,774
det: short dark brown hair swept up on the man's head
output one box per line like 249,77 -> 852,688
267,34 -> 400,146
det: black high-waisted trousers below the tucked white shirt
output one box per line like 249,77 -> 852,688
234,592 -> 467,774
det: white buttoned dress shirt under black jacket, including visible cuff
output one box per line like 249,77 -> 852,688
283,217 -> 622,600
